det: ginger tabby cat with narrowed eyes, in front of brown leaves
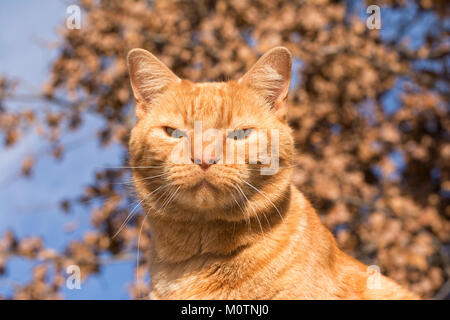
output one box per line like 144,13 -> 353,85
128,47 -> 418,299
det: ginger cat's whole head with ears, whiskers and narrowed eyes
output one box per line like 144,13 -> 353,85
128,47 -> 294,220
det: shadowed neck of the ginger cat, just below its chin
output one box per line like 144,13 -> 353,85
149,184 -> 292,263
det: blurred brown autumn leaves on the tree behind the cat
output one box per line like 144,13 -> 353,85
0,0 -> 450,299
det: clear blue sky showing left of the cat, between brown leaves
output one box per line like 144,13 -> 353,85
0,0 -> 134,299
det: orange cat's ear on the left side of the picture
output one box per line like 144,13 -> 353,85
127,49 -> 181,118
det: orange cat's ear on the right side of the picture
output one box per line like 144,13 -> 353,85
238,47 -> 292,118
